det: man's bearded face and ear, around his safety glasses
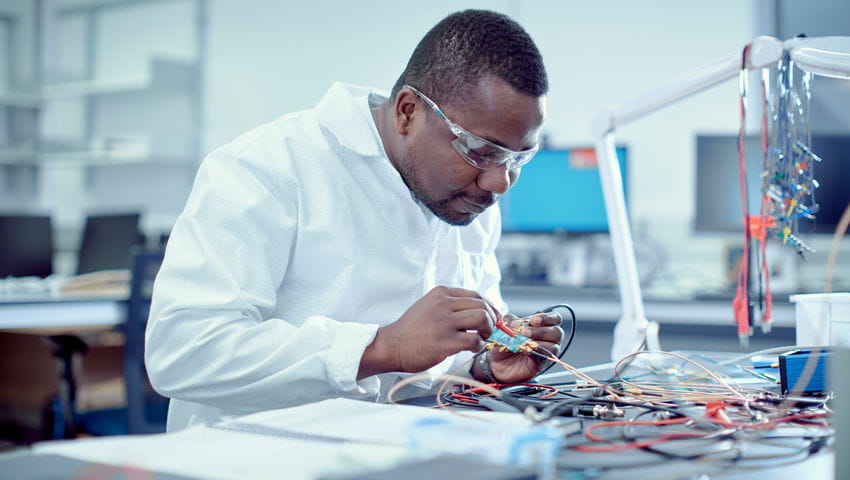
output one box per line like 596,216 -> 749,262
396,77 -> 546,225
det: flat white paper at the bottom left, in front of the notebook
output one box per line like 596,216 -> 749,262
32,427 -> 411,480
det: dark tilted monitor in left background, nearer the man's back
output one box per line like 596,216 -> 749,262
77,213 -> 142,274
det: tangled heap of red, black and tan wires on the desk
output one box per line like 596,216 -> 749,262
441,352 -> 832,475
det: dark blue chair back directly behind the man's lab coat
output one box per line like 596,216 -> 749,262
124,250 -> 168,433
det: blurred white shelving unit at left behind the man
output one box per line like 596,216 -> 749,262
0,0 -> 206,272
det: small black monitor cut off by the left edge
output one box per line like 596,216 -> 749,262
0,214 -> 53,278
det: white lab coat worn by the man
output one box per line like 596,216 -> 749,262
146,84 -> 506,431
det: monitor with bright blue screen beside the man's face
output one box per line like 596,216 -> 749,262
499,147 -> 626,233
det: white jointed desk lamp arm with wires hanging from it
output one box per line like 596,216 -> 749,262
591,36 -> 850,361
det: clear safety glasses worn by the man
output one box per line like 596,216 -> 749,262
402,85 -> 537,170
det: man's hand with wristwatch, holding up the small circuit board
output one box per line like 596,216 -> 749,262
485,312 -> 564,383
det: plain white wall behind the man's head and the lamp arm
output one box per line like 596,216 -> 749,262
203,0 -> 760,292
